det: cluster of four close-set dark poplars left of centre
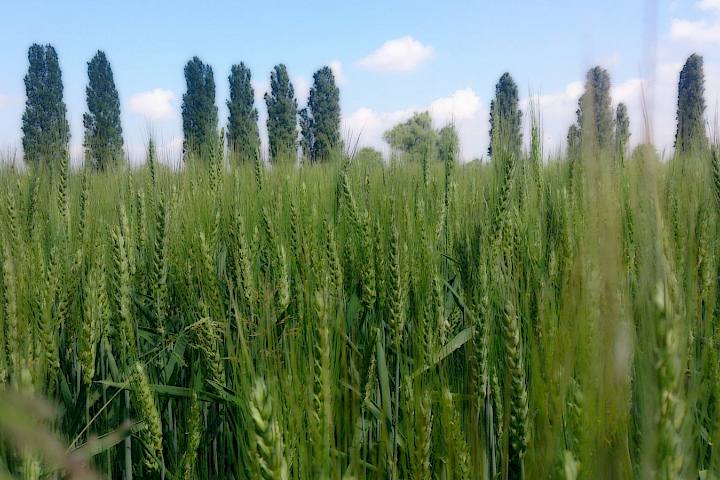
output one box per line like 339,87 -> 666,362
176,57 -> 342,163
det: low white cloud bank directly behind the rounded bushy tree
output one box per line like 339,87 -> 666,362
342,88 -> 488,160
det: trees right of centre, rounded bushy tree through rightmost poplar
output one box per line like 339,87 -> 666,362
390,54 -> 709,165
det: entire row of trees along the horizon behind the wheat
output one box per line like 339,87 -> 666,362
14,44 -> 709,170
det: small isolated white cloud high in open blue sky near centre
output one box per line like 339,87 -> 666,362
358,36 -> 435,72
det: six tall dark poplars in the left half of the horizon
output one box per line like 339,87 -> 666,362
22,44 -> 342,170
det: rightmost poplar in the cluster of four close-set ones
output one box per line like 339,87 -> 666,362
300,66 -> 342,162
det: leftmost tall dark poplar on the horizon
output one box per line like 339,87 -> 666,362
22,44 -> 70,166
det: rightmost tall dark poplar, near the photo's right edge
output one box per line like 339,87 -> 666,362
675,54 -> 708,153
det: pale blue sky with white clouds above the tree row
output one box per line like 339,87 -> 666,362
0,0 -> 720,161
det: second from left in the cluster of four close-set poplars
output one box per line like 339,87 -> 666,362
227,62 -> 260,161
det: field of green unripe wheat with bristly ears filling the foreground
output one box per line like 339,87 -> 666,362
0,137 -> 720,480
